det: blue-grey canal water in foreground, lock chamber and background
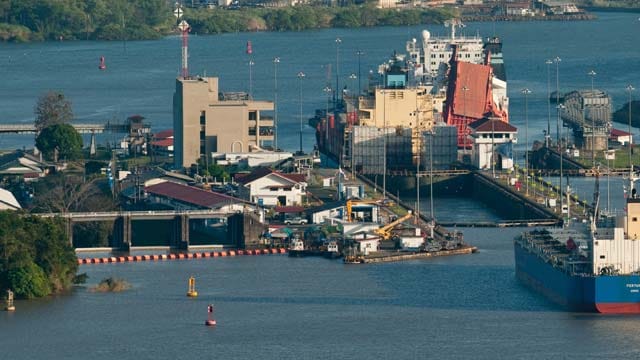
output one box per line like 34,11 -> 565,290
0,13 -> 640,359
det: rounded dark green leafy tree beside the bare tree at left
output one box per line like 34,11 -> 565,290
36,124 -> 82,161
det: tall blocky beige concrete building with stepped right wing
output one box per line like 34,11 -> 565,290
173,77 -> 274,168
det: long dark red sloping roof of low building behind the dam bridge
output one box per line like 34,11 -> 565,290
144,181 -> 244,209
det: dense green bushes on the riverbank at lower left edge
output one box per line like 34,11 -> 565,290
0,211 -> 78,299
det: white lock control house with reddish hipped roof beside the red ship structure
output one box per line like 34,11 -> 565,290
469,118 -> 518,170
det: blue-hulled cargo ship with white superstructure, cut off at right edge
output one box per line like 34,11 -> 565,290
514,176 -> 640,314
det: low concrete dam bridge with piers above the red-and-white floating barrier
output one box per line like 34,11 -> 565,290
33,209 -> 248,251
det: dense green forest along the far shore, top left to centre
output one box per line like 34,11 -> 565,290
0,0 -> 456,42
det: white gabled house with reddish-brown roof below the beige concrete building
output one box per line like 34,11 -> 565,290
235,167 -> 307,206
